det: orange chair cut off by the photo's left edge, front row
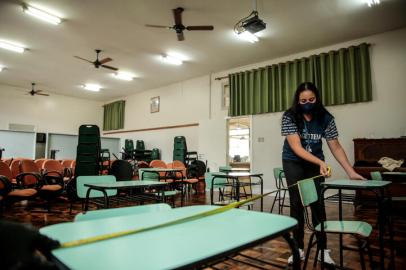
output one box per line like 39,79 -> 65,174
0,162 -> 37,208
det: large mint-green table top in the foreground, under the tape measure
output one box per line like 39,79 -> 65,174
40,205 -> 297,270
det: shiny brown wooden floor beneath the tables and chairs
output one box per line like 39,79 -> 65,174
3,195 -> 406,270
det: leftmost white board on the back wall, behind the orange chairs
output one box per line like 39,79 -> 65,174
0,130 -> 36,159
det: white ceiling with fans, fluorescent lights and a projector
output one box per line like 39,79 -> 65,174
0,0 -> 406,101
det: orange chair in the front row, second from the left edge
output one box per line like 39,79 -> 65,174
16,160 -> 64,211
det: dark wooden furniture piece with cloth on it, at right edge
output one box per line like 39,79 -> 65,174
353,137 -> 406,201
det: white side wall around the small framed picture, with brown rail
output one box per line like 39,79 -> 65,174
107,75 -> 210,162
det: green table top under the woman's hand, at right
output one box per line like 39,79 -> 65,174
320,179 -> 391,189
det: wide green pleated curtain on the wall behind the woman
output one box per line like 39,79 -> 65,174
229,43 -> 372,116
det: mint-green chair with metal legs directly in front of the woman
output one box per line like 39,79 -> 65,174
297,179 -> 372,270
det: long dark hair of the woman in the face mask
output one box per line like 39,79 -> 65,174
286,82 -> 331,130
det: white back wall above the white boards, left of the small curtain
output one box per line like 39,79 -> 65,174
0,85 -> 103,134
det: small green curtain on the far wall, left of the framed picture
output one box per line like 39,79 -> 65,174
103,100 -> 125,130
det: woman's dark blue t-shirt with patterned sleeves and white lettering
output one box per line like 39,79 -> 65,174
281,112 -> 338,160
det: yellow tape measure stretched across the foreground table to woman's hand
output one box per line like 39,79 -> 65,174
58,167 -> 331,248
